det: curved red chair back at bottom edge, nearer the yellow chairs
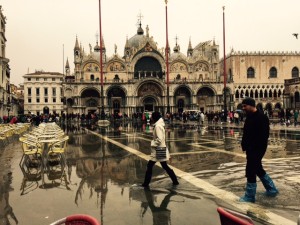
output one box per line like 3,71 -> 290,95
50,214 -> 100,225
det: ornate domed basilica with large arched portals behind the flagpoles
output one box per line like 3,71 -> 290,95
63,18 -> 233,115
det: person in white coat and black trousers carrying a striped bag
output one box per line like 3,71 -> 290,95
142,112 -> 179,187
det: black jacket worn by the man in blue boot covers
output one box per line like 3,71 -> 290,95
242,110 -> 270,154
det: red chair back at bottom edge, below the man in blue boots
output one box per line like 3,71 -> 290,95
217,207 -> 254,225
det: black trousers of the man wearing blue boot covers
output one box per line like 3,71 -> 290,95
246,150 -> 266,183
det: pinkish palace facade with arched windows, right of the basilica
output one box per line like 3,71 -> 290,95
222,51 -> 300,111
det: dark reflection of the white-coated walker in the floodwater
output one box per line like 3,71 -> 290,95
142,189 -> 176,225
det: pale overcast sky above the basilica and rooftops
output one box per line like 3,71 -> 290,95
0,0 -> 300,85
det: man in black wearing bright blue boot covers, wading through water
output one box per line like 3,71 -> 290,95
240,98 -> 278,202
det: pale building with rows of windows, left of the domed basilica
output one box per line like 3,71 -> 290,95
23,71 -> 64,115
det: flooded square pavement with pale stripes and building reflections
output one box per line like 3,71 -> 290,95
0,122 -> 300,225
